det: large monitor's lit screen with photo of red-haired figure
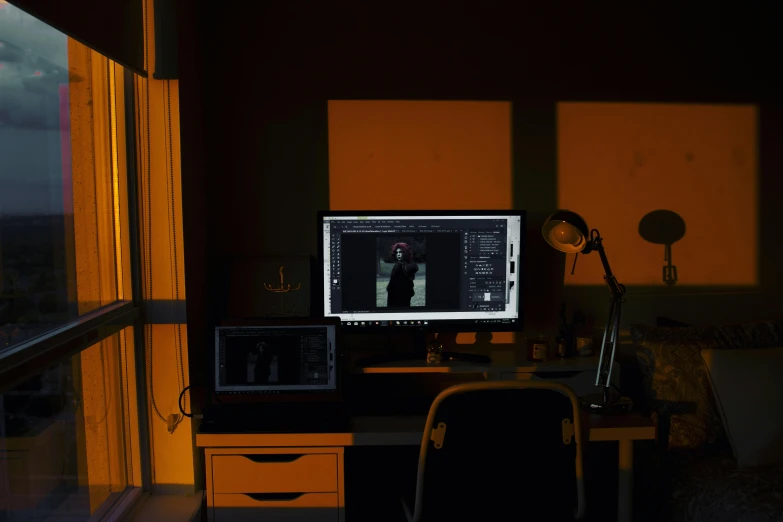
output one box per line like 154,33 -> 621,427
321,212 -> 524,329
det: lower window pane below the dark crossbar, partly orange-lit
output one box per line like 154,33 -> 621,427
0,328 -> 138,522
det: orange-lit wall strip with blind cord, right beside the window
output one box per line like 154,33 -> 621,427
135,0 -> 195,493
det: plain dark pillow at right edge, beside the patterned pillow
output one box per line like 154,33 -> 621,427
702,348 -> 783,468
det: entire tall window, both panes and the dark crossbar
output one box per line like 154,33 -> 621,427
0,0 -> 141,521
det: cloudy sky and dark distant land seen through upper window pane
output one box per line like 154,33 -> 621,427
0,2 -> 76,350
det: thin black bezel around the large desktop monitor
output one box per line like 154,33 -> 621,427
311,209 -> 527,333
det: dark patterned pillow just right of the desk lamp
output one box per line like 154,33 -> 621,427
631,325 -> 723,450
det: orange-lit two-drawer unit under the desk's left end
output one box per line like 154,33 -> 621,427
205,447 -> 345,522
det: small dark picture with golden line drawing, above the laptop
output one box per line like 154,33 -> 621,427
226,256 -> 311,319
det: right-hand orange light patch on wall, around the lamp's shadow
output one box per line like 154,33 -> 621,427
558,103 -> 758,286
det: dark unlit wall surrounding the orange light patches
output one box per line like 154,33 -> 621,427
180,2 -> 780,406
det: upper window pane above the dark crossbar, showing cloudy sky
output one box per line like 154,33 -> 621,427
0,3 -> 130,353
